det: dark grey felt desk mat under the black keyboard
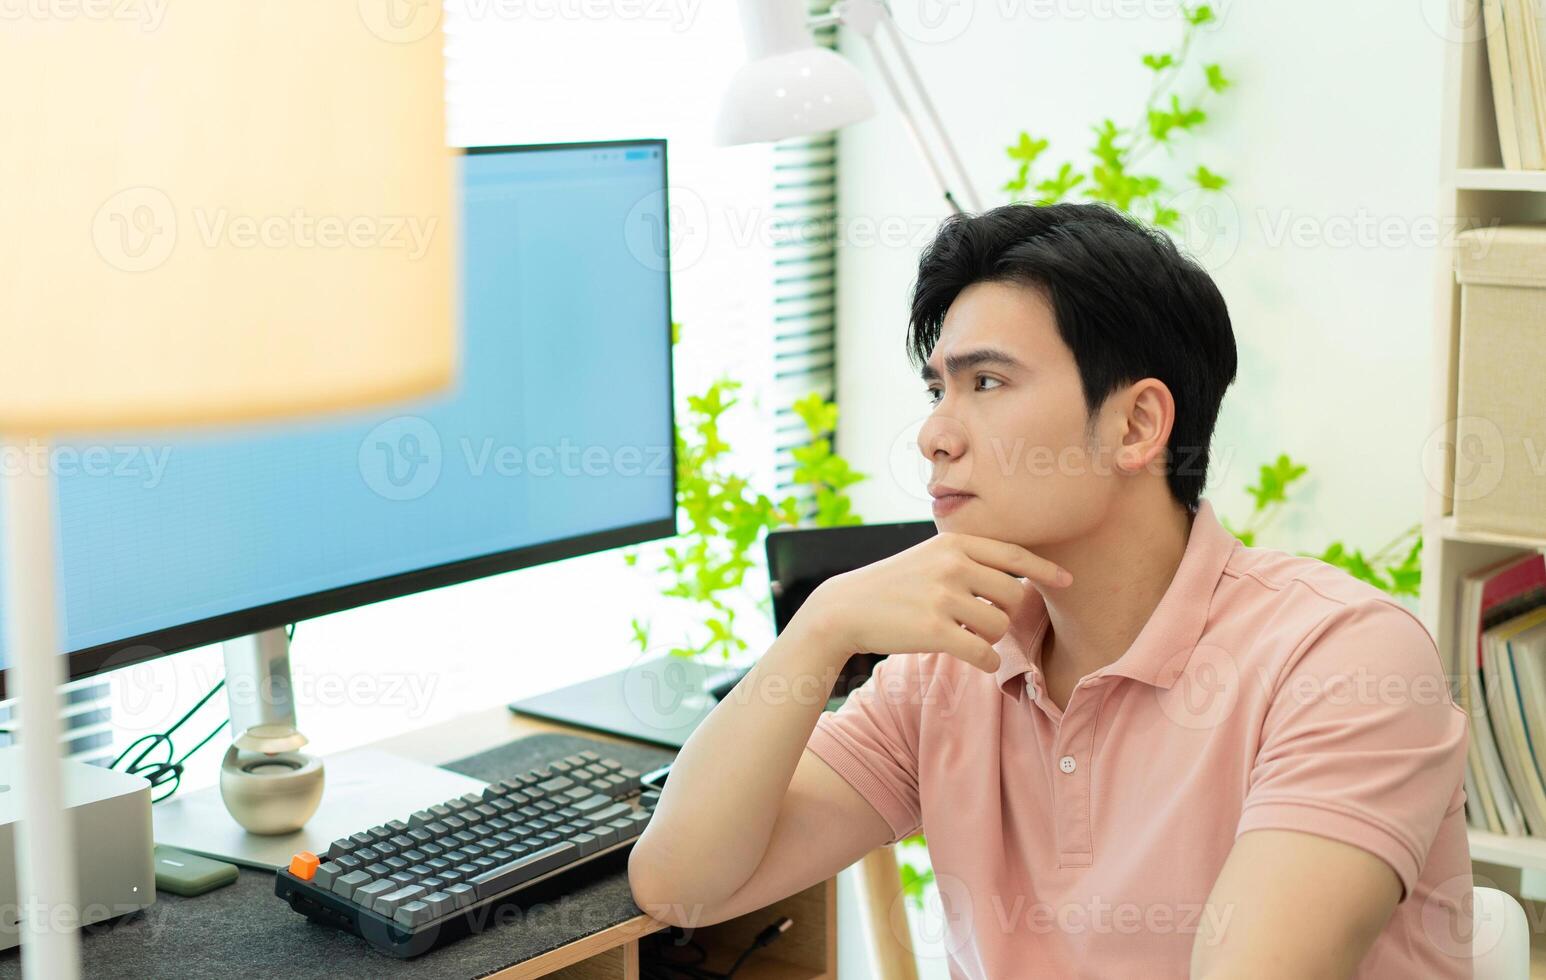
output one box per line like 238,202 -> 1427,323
0,733 -> 676,980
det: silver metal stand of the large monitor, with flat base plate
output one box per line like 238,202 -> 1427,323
152,628 -> 487,869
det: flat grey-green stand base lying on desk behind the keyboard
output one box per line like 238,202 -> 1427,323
510,655 -> 750,748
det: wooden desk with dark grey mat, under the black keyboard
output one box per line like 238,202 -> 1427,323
0,705 -> 838,980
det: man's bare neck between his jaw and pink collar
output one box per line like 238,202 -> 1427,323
1031,495 -> 1194,688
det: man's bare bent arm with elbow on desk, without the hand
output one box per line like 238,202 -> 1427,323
628,617 -> 892,927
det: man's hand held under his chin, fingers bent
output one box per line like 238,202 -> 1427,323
795,532 -> 1073,672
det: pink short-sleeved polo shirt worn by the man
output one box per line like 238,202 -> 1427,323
809,499 -> 1472,980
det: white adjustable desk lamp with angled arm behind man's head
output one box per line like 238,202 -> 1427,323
714,0 -> 982,213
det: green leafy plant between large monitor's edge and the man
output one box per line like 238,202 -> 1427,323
623,323 -> 867,660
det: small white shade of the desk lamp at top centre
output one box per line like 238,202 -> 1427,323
714,0 -> 875,145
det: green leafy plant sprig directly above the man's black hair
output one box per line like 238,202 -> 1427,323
1003,3 -> 1231,229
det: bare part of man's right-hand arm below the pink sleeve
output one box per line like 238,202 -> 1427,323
1192,830 -> 1401,980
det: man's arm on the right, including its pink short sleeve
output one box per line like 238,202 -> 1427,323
1192,600 -> 1469,980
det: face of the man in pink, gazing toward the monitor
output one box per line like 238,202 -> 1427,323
918,283 -> 1115,547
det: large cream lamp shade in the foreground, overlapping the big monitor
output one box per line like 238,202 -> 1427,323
0,0 -> 456,434
